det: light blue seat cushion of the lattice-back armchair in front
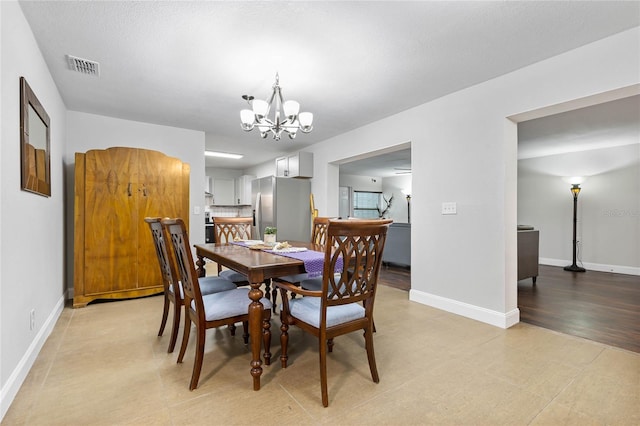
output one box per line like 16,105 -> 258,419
289,296 -> 365,327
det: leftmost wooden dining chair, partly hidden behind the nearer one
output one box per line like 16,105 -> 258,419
144,217 -> 236,353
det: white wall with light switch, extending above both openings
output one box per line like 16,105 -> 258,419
307,28 -> 640,327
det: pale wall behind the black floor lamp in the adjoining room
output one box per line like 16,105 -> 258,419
518,144 -> 640,275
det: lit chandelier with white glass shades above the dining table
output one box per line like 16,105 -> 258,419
240,73 -> 313,141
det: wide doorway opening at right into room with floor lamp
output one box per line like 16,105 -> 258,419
510,86 -> 640,351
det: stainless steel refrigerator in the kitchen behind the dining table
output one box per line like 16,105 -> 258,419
251,176 -> 311,241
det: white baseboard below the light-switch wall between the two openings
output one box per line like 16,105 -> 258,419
409,289 -> 520,328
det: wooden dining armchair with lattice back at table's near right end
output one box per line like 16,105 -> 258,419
276,220 -> 392,407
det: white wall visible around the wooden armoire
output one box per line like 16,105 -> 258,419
64,111 -> 205,296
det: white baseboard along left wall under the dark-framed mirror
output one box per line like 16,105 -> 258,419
0,295 -> 65,421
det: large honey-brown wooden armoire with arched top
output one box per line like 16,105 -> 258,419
73,147 -> 190,308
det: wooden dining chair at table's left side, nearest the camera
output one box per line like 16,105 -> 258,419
161,218 -> 271,390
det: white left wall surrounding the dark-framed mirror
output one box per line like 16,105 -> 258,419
0,1 -> 66,416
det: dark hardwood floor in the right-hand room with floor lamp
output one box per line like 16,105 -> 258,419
518,265 -> 640,353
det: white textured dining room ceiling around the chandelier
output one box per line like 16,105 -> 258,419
20,1 -> 640,169
